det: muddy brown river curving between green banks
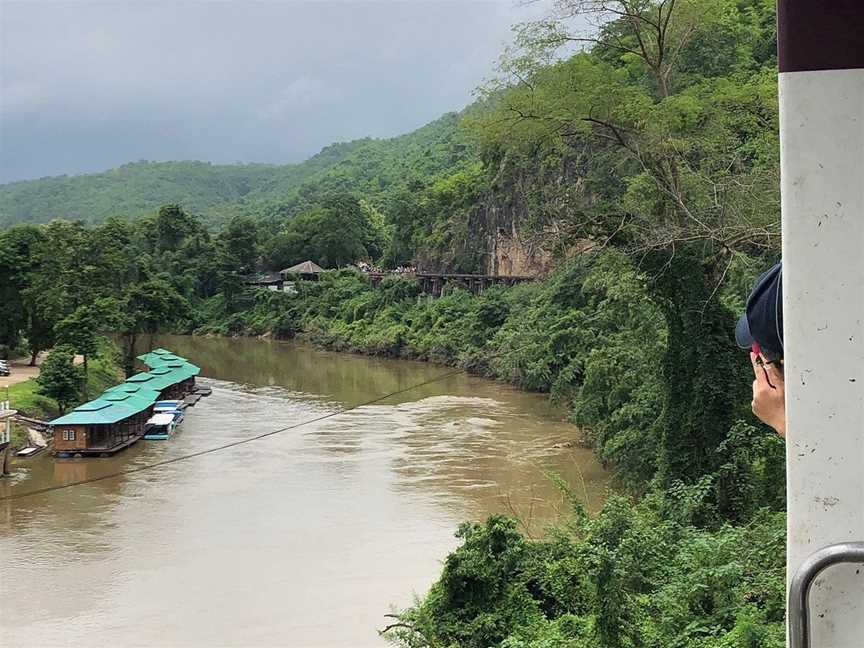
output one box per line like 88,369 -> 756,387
0,337 -> 607,648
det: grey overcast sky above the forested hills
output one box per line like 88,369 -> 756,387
0,0 -> 544,182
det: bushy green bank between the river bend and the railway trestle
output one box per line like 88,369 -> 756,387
196,252 -> 665,487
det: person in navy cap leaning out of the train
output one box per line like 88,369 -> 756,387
735,263 -> 786,436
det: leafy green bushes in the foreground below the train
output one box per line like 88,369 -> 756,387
384,495 -> 785,648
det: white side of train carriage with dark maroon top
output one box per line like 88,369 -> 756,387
779,0 -> 864,648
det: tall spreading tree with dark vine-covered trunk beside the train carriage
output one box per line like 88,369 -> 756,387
473,0 -> 779,484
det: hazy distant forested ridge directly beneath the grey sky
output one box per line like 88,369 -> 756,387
0,113 -> 467,227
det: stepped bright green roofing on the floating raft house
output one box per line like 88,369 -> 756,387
50,349 -> 201,425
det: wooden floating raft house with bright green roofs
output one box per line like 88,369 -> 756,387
49,349 -> 201,456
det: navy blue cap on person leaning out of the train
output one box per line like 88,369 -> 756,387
735,263 -> 783,360
